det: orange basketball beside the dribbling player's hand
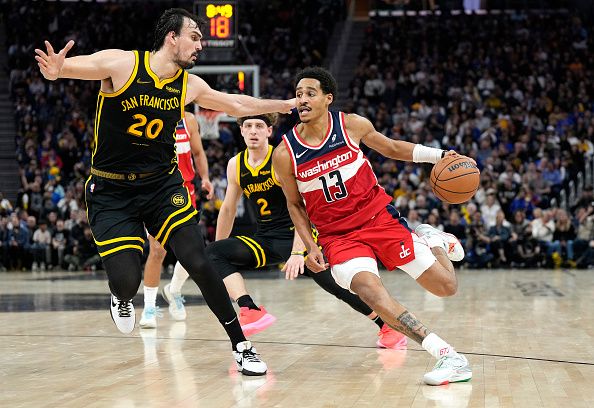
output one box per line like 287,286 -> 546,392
429,156 -> 481,204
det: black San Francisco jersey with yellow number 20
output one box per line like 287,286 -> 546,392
92,51 -> 188,173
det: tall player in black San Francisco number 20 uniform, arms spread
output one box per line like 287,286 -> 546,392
35,9 -> 295,375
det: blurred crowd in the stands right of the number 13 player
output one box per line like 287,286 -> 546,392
346,13 -> 594,267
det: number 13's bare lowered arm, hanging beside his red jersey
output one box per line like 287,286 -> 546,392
272,143 -> 328,272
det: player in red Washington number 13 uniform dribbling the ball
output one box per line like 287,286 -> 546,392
273,68 -> 472,385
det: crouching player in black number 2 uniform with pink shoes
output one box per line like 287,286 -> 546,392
164,114 -> 407,349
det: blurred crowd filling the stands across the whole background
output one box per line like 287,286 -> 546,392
0,0 -> 594,270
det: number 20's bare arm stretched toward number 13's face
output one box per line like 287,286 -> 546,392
186,75 -> 295,118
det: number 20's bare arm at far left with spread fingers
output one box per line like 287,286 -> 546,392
35,40 -> 134,81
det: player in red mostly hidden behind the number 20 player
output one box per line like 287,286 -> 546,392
139,112 -> 213,329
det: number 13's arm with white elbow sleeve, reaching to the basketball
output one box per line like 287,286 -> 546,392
345,114 -> 458,163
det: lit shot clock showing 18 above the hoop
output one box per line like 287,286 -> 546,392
195,0 -> 237,49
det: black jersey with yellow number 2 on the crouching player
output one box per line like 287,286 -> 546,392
235,146 -> 293,238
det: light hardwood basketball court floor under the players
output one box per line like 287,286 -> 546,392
0,270 -> 594,408
